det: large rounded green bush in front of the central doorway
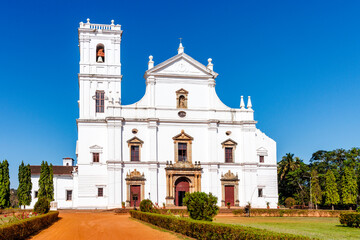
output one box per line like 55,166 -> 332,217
184,192 -> 219,221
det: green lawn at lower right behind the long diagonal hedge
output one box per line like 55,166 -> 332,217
215,216 -> 360,239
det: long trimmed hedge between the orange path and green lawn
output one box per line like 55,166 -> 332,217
130,210 -> 310,240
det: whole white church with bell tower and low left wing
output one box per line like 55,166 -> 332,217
31,19 -> 278,209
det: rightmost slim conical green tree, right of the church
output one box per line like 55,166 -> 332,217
341,167 -> 357,208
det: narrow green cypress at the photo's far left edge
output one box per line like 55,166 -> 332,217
0,159 -> 10,208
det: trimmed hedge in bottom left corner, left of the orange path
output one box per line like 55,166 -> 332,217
0,212 -> 59,240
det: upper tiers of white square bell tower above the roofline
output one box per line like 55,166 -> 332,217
78,18 -> 122,119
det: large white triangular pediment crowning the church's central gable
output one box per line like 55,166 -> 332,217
145,53 -> 218,78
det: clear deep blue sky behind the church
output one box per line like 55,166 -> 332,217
0,0 -> 360,187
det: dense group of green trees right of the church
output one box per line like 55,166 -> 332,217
278,148 -> 360,208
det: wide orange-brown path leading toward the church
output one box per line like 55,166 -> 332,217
31,211 -> 178,240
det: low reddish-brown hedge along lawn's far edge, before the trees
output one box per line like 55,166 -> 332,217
233,208 -> 349,217
